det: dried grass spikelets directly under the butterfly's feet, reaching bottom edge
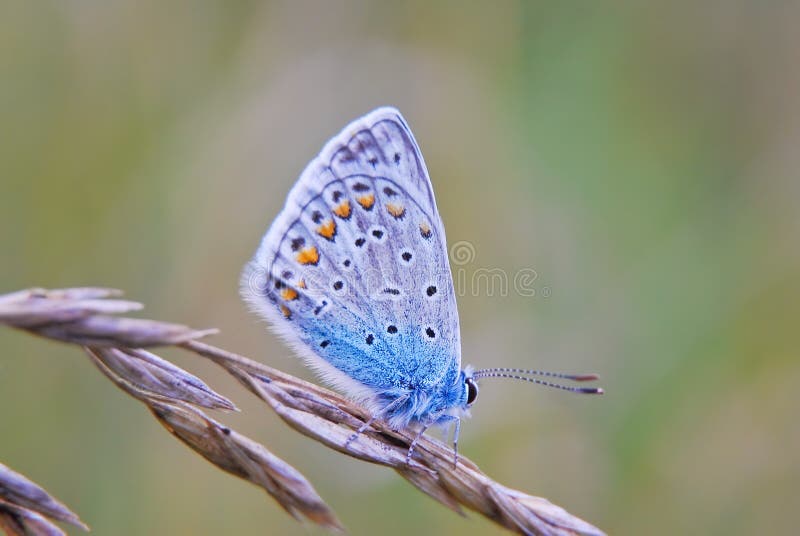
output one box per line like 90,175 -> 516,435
181,341 -> 603,535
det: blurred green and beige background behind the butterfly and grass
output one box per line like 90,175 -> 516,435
0,0 -> 800,535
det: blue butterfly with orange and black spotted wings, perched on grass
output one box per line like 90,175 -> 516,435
241,107 -> 602,464
